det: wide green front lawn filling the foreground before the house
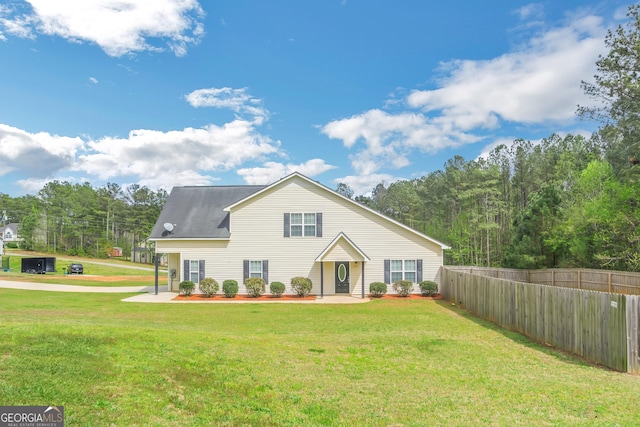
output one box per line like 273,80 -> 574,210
0,290 -> 640,426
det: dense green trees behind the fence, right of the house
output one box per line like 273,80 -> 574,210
338,135 -> 640,271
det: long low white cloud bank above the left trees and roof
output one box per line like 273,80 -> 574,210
0,120 -> 282,191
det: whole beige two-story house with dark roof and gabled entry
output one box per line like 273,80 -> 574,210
150,172 -> 449,296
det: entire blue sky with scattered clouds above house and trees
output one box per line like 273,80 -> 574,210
0,0 -> 629,196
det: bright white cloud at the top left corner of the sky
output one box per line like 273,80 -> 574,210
0,0 -> 204,56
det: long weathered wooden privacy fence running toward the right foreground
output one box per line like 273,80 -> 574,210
440,267 -> 640,374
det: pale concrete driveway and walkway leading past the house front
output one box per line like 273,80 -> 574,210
0,280 -> 369,304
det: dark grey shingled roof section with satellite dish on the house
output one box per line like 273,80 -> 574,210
150,185 -> 266,239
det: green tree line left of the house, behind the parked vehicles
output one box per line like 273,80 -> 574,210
0,181 -> 168,258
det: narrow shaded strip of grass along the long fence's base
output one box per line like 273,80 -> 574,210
436,299 -> 614,371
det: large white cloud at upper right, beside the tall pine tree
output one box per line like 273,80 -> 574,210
407,16 -> 604,131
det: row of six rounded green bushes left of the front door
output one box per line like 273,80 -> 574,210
178,277 -> 313,298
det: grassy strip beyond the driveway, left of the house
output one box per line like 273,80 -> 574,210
0,252 -> 167,286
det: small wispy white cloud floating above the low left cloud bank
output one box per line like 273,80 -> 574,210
185,87 -> 269,125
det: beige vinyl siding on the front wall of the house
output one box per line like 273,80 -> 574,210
157,178 -> 442,296
